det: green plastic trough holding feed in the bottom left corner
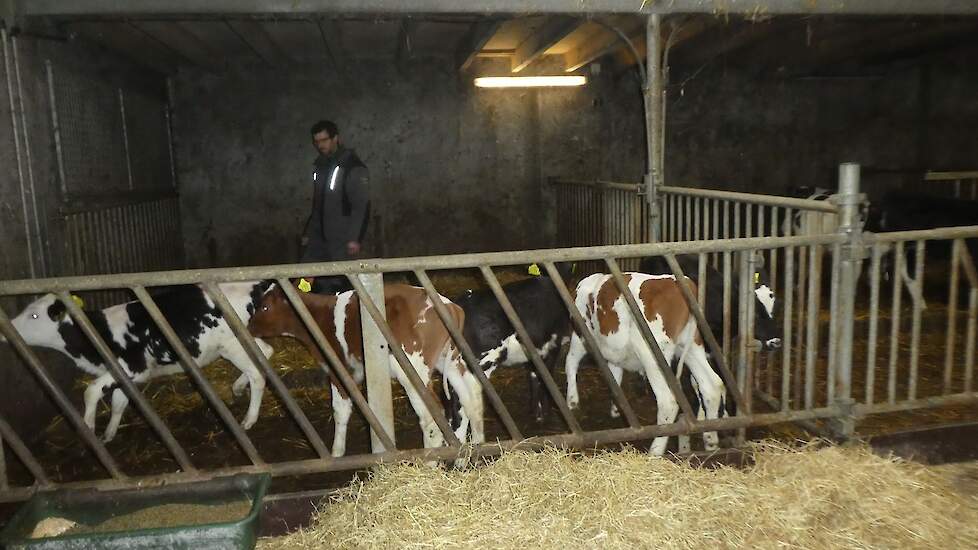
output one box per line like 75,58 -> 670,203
0,474 -> 270,550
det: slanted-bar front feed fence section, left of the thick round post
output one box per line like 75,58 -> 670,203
0,235 -> 840,500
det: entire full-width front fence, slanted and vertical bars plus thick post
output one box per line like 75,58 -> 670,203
0,165 -> 978,501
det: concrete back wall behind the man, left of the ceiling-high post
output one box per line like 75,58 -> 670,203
174,59 -> 644,266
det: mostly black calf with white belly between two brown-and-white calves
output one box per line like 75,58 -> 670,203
446,276 -> 570,429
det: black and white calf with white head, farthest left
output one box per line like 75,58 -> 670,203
0,282 -> 272,441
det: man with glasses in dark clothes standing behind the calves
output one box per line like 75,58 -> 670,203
300,120 -> 370,292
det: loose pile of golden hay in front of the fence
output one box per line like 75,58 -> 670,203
258,443 -> 978,550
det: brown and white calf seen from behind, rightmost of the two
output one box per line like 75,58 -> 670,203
566,273 -> 726,455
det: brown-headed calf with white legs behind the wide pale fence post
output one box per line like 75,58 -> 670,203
248,284 -> 484,456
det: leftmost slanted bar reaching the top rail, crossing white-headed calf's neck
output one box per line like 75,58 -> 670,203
57,292 -> 197,472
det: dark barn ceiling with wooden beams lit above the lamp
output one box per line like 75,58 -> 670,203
13,14 -> 978,76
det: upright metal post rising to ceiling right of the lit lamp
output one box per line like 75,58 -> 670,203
642,14 -> 665,242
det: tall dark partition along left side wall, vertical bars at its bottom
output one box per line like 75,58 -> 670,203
46,60 -> 184,307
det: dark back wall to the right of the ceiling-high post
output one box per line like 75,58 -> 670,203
666,48 -> 978,196
